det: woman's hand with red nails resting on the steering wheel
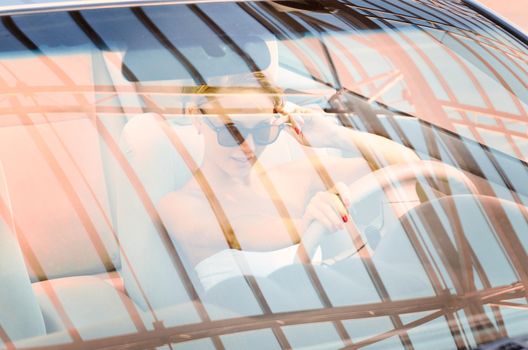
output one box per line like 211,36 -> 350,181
302,182 -> 351,232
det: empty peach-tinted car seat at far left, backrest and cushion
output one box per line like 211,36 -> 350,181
0,106 -> 141,339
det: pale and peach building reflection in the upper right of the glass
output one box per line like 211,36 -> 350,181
270,2 -> 528,159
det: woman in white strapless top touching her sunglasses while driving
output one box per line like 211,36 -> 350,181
159,91 -> 416,287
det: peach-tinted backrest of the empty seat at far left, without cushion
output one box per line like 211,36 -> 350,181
0,116 -> 119,281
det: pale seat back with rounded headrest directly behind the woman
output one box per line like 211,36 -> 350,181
117,114 -> 202,309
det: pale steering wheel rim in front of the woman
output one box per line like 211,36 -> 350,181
295,160 -> 479,263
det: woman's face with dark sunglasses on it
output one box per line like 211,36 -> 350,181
197,95 -> 282,178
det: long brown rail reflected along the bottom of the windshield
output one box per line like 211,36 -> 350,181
10,283 -> 526,350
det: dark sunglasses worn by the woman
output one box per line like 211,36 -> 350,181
204,117 -> 286,147
